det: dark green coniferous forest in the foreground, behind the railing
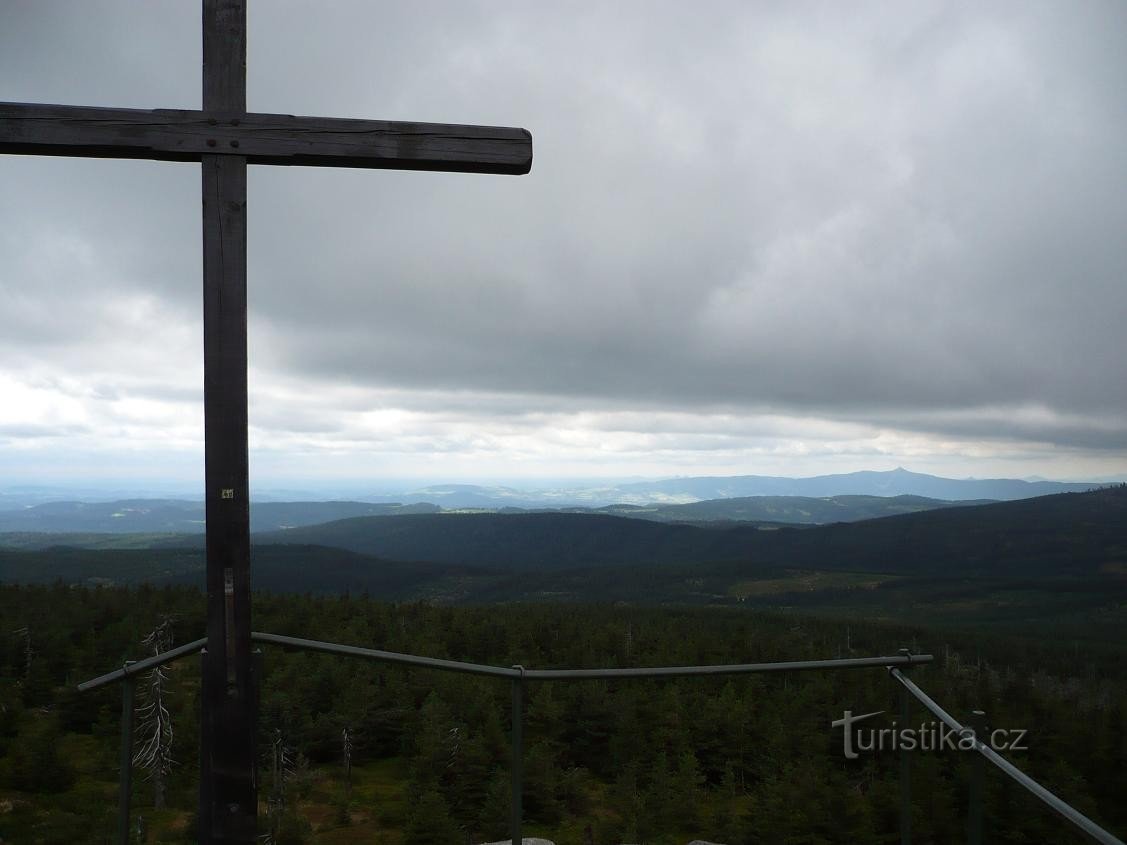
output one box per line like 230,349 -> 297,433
0,584 -> 1127,845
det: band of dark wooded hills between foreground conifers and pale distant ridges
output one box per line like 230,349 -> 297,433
0,487 -> 1127,641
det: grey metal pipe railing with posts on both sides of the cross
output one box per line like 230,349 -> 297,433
78,631 -> 1125,845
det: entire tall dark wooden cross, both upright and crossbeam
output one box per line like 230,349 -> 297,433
0,0 -> 532,844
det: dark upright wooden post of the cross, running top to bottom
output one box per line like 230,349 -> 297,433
199,0 -> 258,845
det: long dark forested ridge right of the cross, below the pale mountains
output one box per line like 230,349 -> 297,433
255,487 -> 1127,575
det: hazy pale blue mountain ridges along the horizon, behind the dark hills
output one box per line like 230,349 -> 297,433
0,469 -> 1099,533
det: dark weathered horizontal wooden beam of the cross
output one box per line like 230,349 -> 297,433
0,103 -> 532,176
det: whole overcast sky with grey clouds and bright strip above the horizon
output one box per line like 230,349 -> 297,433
0,0 -> 1127,486
